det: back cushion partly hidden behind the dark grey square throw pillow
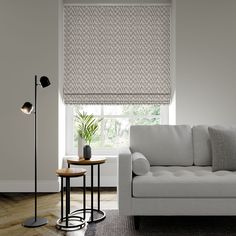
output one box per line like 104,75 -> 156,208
192,125 -> 212,166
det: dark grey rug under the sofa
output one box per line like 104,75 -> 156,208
85,210 -> 236,236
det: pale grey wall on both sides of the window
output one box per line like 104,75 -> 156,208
0,0 -> 236,192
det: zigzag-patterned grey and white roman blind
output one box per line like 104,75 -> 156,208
64,5 -> 171,104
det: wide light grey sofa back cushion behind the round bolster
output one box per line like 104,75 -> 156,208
130,125 -> 193,166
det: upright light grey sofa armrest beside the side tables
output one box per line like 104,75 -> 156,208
118,147 -> 132,215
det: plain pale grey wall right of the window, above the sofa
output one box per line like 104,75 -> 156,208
175,0 -> 236,125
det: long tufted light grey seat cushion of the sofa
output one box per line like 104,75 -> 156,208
133,166 -> 236,198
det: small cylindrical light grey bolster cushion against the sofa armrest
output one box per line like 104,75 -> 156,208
132,152 -> 150,175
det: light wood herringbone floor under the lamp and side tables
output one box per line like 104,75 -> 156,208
0,188 -> 117,236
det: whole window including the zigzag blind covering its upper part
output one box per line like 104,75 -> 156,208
64,0 -> 171,155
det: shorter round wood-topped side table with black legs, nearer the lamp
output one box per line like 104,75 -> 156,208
56,168 -> 87,231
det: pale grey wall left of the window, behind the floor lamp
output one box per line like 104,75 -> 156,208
0,0 -> 59,192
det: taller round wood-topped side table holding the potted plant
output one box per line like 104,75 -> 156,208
67,157 -> 106,223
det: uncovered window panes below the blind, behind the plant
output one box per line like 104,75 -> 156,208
66,105 -> 168,155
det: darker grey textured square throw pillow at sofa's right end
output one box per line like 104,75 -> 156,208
209,126 -> 236,171
